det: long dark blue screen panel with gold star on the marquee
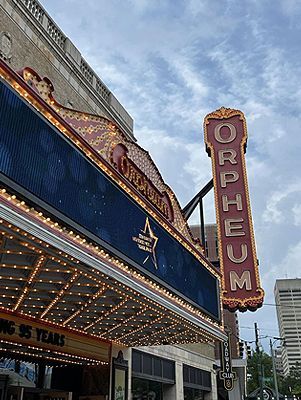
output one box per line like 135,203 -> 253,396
0,79 -> 220,319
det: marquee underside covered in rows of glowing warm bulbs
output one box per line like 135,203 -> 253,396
0,216 -> 223,356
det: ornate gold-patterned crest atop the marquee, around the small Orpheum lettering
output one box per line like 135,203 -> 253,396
20,67 -> 204,254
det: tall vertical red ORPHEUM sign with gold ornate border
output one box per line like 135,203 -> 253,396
204,107 -> 264,311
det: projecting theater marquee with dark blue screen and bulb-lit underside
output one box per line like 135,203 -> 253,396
0,57 -> 224,361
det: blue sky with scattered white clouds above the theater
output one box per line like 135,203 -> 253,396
41,0 -> 301,347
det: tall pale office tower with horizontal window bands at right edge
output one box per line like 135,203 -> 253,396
274,279 -> 301,376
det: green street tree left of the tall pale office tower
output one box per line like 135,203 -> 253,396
247,351 -> 274,394
